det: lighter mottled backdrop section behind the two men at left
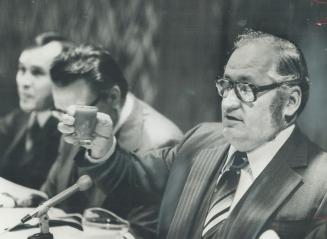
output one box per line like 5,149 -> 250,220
0,0 -> 158,113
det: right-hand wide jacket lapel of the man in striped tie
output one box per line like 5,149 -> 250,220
217,129 -> 307,239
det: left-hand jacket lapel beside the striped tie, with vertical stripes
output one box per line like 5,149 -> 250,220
167,144 -> 229,239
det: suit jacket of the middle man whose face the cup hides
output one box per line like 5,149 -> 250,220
42,95 -> 182,238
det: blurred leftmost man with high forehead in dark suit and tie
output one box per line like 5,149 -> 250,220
0,33 -> 68,189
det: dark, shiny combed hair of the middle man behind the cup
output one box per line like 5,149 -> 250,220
50,45 -> 128,99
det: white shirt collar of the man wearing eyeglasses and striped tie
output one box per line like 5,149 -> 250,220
225,124 -> 295,179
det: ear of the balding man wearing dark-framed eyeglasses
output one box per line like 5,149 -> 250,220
284,86 -> 302,119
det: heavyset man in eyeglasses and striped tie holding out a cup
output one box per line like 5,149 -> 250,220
59,31 -> 327,239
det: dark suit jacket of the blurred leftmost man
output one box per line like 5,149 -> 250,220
0,110 -> 60,189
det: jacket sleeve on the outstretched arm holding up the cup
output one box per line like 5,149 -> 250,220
76,123 -> 205,204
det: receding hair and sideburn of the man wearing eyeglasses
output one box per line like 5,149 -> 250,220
234,30 -> 310,115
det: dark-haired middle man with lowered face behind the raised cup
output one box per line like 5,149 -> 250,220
42,45 -> 182,238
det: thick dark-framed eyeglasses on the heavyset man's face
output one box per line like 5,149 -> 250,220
216,78 -> 301,102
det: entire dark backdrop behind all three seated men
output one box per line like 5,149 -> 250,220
0,0 -> 327,148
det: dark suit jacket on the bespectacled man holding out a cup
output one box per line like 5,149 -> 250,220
79,123 -> 327,239
